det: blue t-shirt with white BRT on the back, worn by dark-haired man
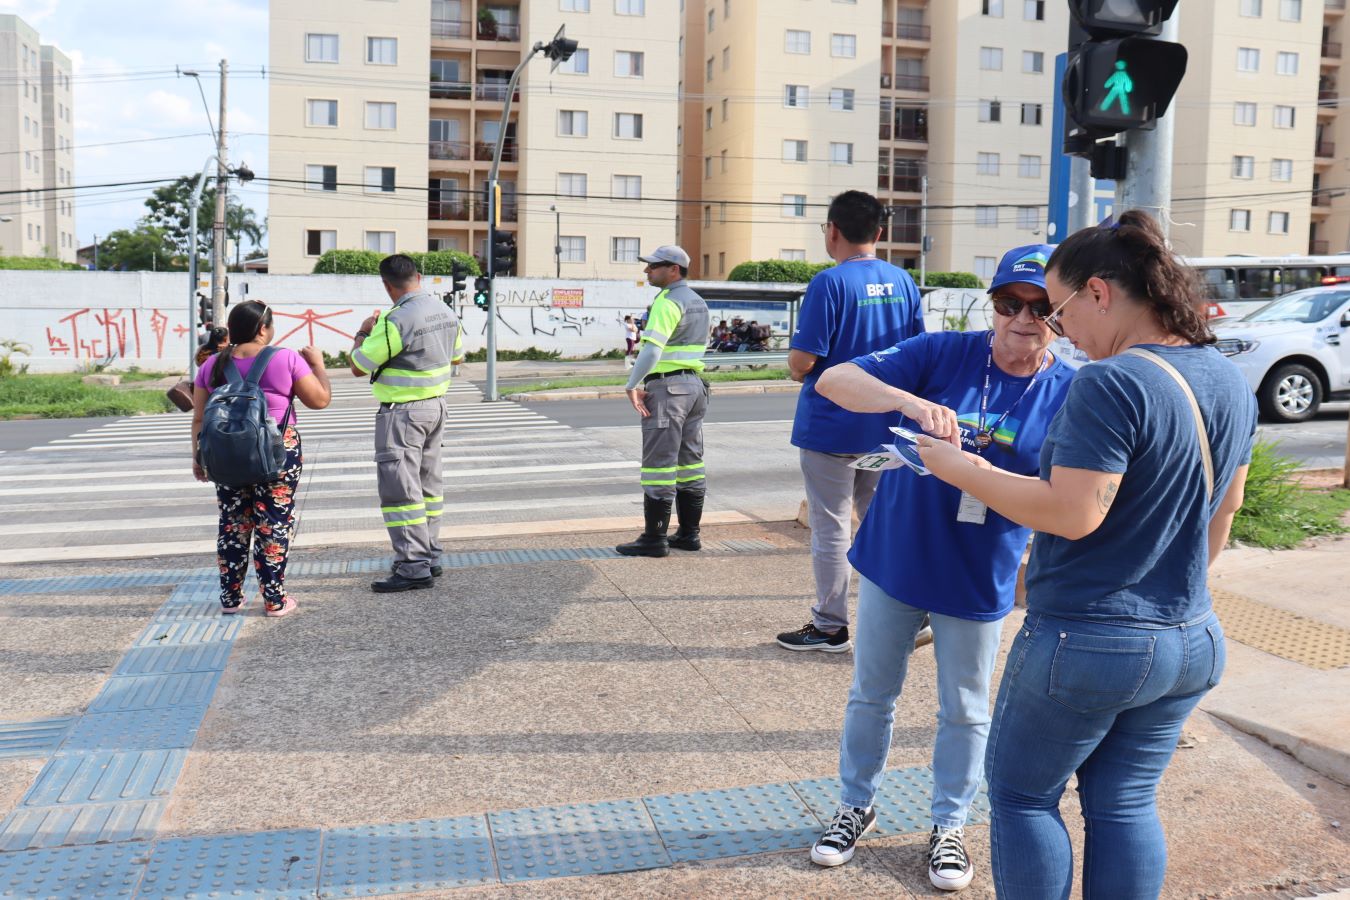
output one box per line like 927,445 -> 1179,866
788,258 -> 923,453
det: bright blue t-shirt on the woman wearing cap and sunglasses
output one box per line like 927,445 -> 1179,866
849,332 -> 1073,622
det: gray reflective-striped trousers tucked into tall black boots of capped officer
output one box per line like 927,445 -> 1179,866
643,371 -> 707,499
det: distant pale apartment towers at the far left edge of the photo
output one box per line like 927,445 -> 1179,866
0,15 -> 77,263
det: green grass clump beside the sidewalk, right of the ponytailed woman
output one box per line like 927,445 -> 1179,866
1233,441 -> 1350,551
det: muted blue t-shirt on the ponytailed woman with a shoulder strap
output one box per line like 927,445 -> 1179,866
1026,344 -> 1257,625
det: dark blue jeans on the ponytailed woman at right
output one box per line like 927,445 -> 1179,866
986,613 -> 1226,900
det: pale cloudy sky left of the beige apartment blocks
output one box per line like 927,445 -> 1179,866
0,0 -> 267,246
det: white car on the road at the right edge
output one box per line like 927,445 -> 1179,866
1214,285 -> 1350,422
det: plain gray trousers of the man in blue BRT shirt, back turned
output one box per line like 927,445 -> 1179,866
801,449 -> 882,631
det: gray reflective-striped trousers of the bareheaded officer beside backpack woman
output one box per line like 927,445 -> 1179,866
375,397 -> 446,578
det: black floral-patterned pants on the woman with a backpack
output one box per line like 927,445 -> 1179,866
216,425 -> 304,609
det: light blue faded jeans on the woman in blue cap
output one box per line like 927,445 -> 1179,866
840,578 -> 1003,828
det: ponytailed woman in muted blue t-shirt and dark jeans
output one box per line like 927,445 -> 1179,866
919,210 -> 1257,900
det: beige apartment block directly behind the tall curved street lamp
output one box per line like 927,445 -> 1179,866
269,0 -> 680,278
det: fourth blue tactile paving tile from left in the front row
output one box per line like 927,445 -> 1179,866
487,800 -> 671,882
